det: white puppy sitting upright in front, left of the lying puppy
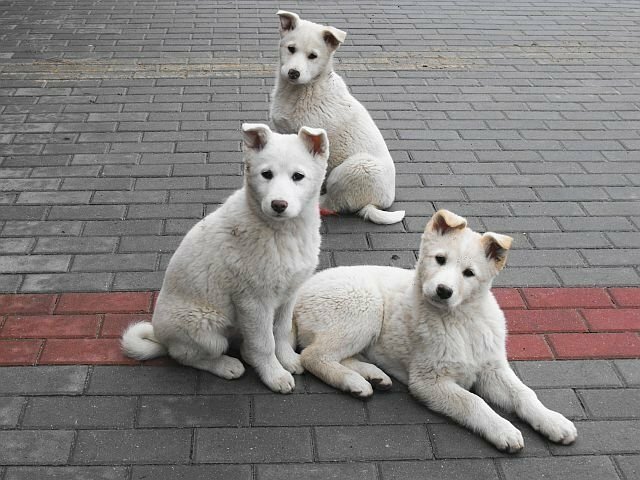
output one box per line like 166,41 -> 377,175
122,124 -> 329,393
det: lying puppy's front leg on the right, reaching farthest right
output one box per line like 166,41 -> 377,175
476,362 -> 578,445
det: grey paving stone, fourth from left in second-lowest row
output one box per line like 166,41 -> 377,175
314,425 -> 433,461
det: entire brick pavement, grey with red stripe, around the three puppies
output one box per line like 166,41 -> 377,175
0,0 -> 640,480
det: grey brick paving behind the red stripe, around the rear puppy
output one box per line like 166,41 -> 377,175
0,0 -> 640,292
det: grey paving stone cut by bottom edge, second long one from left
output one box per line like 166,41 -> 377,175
131,465 -> 253,480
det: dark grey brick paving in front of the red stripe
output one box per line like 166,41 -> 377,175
0,360 -> 640,480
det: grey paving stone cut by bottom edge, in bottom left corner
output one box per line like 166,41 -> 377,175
4,466 -> 128,480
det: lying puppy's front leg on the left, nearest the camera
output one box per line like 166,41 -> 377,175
409,372 -> 524,453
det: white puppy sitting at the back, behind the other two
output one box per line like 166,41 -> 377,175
271,10 -> 404,224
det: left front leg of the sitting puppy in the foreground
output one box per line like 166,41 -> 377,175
236,301 -> 295,393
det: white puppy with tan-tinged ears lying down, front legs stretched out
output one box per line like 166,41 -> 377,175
294,210 -> 577,452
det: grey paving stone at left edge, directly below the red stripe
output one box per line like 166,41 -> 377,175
0,365 -> 88,395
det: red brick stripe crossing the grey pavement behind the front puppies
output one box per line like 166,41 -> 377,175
0,287 -> 640,365
